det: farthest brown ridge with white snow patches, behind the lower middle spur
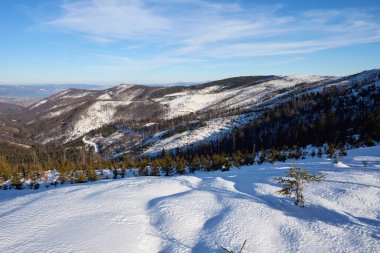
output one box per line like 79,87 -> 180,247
8,70 -> 380,146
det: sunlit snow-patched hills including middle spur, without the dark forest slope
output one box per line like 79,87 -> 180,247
0,70 -> 380,156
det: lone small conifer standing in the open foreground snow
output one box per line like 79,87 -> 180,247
274,167 -> 325,207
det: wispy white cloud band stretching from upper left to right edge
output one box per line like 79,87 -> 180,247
45,0 -> 380,62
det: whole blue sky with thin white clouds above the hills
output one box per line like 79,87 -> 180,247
0,0 -> 380,85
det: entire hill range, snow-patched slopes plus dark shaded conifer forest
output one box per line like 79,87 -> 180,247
0,70 -> 380,166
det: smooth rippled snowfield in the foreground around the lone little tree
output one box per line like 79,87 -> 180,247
0,146 -> 380,253
